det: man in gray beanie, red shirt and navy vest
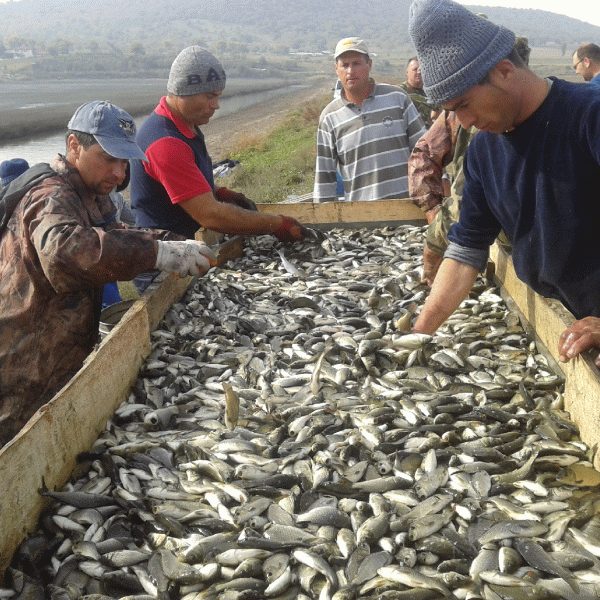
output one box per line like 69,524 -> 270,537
131,46 -> 304,291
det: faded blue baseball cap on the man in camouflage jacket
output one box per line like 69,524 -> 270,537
67,100 -> 147,162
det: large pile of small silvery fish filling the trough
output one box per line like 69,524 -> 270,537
5,226 -> 600,600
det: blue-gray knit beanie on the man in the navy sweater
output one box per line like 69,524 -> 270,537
408,0 -> 515,104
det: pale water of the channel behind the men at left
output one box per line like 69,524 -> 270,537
0,86 -> 300,165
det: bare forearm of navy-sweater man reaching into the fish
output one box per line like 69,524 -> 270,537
413,258 -> 478,334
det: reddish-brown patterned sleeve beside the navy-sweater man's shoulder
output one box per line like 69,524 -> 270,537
408,110 -> 460,212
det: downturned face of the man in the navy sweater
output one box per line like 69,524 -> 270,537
442,83 -> 520,133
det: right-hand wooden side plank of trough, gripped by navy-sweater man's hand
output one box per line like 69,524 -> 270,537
490,244 -> 600,469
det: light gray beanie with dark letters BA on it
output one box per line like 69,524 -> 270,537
167,46 -> 225,96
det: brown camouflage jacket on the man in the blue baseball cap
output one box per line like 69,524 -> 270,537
0,156 -> 182,443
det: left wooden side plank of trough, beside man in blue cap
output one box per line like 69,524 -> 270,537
0,277 -> 192,584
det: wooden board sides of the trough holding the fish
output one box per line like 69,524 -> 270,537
0,200 -> 600,585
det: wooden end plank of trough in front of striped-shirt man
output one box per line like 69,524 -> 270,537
258,198 -> 426,228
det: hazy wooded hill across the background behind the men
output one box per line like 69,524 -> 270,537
0,0 -> 600,77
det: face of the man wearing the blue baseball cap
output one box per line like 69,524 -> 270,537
67,135 -> 129,195
